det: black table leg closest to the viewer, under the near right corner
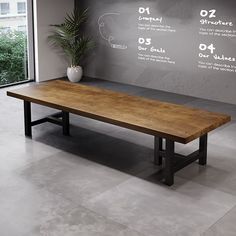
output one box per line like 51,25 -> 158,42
164,139 -> 175,186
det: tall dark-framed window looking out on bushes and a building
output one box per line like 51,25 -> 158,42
0,0 -> 34,88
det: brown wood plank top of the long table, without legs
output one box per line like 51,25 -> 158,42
7,80 -> 231,144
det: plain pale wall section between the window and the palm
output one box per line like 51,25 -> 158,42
34,0 -> 74,82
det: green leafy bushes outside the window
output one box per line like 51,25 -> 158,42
0,30 -> 27,86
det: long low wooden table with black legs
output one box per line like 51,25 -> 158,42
7,80 -> 231,185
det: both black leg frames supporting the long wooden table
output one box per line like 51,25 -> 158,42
24,101 -> 208,186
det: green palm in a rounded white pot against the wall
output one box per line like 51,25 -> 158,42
48,9 -> 94,82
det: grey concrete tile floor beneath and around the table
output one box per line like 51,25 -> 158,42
0,79 -> 236,236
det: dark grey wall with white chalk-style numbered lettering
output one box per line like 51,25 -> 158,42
77,0 -> 236,104
